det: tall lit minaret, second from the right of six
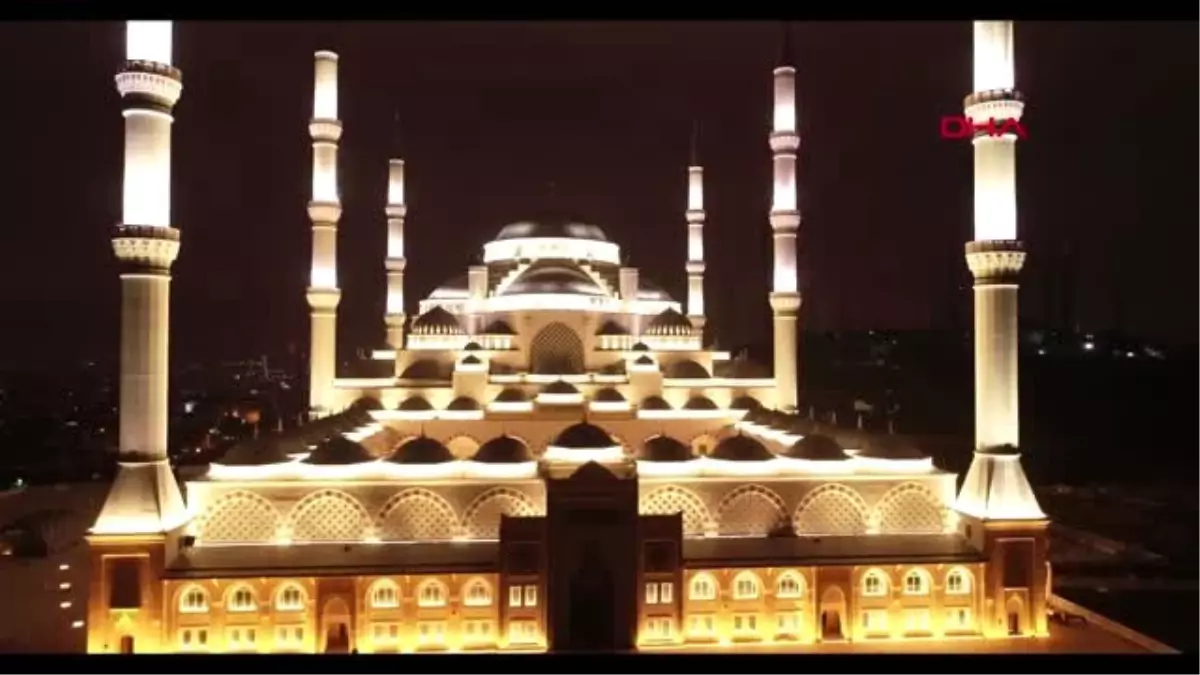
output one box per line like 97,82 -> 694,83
770,26 -> 800,412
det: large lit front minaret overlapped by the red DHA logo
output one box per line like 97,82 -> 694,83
958,22 -> 1045,520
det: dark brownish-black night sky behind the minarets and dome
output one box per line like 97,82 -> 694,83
0,22 -> 1200,365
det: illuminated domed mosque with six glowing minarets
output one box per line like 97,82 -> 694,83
88,22 -> 1050,653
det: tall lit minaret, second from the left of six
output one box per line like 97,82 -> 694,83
308,52 -> 342,417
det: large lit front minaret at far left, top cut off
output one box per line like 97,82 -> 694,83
91,22 -> 187,536
